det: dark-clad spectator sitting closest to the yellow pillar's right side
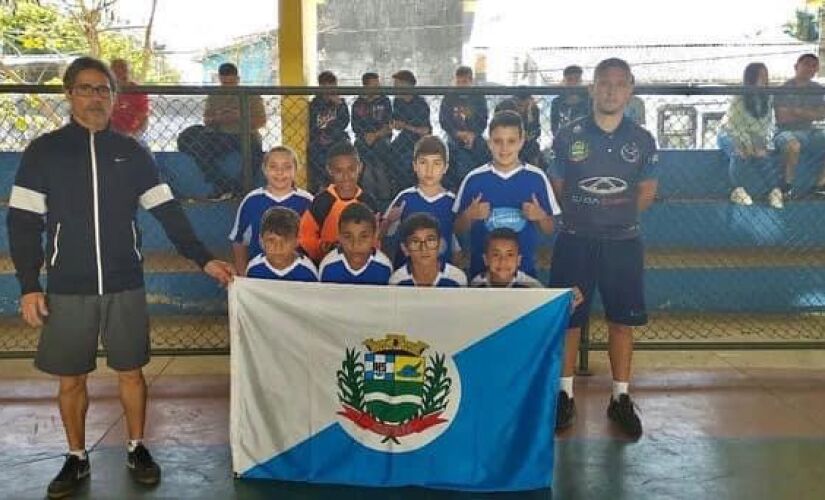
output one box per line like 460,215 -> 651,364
307,71 -> 349,194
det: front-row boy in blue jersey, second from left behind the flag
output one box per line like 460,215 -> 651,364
319,203 -> 392,285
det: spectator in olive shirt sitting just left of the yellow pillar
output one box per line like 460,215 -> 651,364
178,63 -> 266,200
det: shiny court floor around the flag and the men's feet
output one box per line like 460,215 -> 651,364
0,351 -> 825,500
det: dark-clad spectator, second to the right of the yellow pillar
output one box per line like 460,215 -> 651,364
352,73 -> 393,202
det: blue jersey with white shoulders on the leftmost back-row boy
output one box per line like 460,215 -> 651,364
229,187 -> 312,255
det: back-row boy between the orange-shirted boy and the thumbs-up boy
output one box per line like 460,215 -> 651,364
381,135 -> 455,267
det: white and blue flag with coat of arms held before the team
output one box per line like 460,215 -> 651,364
229,278 -> 570,491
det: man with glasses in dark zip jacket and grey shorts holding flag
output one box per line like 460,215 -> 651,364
8,57 -> 233,498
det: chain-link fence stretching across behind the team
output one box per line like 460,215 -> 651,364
0,86 -> 825,353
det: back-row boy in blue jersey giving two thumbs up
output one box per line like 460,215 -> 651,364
453,111 -> 560,276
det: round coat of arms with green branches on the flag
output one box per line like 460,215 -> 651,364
337,334 -> 461,452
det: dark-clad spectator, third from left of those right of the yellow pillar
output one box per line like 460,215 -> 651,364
390,69 -> 432,195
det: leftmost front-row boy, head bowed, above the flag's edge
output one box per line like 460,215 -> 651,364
246,207 -> 318,281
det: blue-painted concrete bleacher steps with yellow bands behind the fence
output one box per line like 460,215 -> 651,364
0,150 -> 825,315
